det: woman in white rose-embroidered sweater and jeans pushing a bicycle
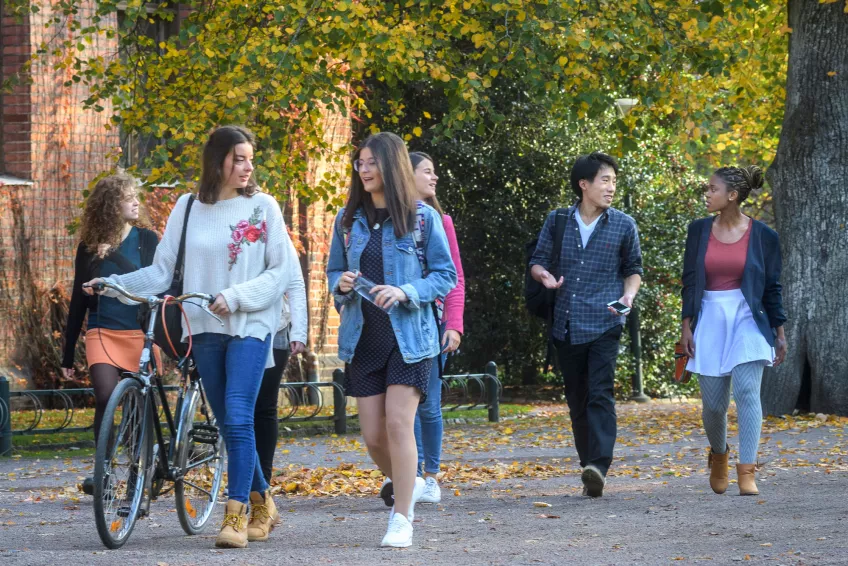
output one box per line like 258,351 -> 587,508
89,126 -> 300,548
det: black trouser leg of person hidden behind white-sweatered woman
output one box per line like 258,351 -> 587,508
253,350 -> 290,484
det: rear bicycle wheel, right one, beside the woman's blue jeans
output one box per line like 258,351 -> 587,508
174,387 -> 225,535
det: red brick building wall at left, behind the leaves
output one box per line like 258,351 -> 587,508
0,0 -> 351,379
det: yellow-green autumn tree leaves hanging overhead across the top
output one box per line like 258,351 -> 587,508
4,0 -> 791,204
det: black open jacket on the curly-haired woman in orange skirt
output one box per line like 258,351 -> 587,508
62,228 -> 159,368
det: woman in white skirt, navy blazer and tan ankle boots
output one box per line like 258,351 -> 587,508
680,166 -> 786,495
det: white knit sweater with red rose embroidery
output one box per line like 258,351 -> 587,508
107,193 -> 300,367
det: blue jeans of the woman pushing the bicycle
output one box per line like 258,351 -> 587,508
192,332 -> 271,503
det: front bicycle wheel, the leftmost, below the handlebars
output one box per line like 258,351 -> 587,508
94,378 -> 153,549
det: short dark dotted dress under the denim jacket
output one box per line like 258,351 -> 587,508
345,209 -> 433,401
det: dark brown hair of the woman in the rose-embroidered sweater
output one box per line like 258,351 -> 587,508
197,126 -> 259,204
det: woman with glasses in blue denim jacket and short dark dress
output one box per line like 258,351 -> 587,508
327,132 -> 457,547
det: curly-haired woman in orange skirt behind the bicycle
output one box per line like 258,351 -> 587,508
62,173 -> 159,495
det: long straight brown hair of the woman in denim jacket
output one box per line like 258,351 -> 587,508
342,132 -> 418,238
